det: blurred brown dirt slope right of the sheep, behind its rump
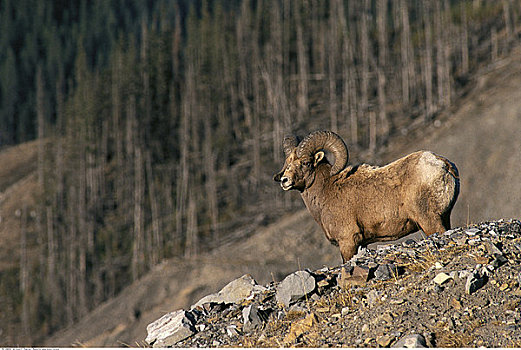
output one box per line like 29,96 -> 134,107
384,49 -> 521,226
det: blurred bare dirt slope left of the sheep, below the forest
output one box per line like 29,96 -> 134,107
46,211 -> 341,346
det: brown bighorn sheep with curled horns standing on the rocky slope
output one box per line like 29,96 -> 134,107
274,131 -> 460,262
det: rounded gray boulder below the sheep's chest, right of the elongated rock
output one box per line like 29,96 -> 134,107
275,271 -> 316,307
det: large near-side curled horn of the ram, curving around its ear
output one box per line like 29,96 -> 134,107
297,131 -> 349,175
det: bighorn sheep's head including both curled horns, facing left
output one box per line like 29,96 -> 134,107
273,131 -> 348,192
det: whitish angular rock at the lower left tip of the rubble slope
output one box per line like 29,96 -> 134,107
145,310 -> 196,348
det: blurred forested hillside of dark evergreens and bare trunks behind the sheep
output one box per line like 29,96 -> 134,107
0,0 -> 521,345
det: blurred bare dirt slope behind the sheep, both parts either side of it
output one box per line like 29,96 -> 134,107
45,50 -> 521,346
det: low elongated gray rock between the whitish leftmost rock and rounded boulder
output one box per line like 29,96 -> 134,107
191,275 -> 266,309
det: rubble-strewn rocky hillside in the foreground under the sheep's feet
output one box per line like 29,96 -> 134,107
146,220 -> 521,347
